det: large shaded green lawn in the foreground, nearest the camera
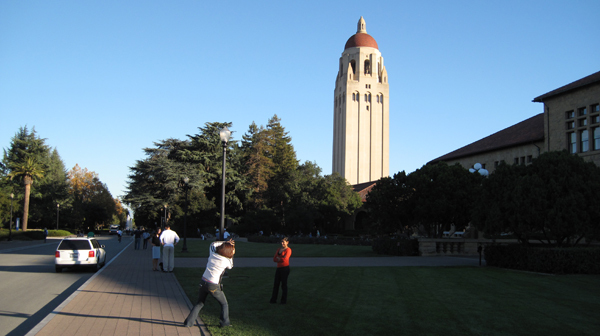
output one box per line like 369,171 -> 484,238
175,245 -> 600,336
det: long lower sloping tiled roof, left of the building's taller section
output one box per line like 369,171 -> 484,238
428,113 -> 544,163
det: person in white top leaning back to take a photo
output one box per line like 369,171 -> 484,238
183,239 -> 235,328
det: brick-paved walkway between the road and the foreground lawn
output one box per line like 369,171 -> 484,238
28,243 -> 210,336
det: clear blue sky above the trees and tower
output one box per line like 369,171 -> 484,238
0,0 -> 600,197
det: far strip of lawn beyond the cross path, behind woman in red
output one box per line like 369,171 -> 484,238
175,239 -> 383,258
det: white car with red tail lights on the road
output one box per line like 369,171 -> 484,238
54,237 -> 106,273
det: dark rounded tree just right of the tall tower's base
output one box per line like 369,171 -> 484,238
367,162 -> 482,237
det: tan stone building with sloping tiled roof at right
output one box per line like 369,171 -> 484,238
428,72 -> 600,173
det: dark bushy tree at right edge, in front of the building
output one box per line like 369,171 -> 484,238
474,151 -> 600,246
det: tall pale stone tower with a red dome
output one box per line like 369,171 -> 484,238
332,17 -> 389,185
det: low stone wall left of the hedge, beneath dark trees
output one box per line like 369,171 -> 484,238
419,238 -> 492,256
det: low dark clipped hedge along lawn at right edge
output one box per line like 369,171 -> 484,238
484,245 -> 600,274
